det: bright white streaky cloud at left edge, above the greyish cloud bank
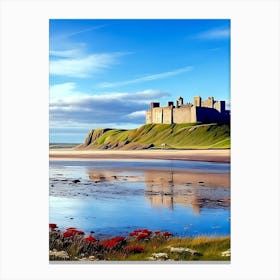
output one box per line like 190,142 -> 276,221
50,53 -> 122,78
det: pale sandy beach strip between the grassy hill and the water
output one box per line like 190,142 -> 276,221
49,149 -> 230,162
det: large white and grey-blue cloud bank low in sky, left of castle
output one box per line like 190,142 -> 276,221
50,83 -> 169,126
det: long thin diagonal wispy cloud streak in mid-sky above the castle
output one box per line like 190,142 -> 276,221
99,66 -> 193,88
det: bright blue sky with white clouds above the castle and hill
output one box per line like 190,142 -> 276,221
49,19 -> 230,143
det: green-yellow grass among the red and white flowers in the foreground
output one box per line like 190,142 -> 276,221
51,231 -> 230,261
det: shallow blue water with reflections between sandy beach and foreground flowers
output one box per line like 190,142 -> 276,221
49,160 -> 230,237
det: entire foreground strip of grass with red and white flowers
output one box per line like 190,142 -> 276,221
49,224 -> 230,261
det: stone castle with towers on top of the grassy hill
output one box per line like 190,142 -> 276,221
146,96 -> 230,124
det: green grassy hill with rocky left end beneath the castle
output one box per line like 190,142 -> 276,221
76,123 -> 230,150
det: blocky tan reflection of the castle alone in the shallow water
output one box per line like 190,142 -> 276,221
144,171 -> 230,215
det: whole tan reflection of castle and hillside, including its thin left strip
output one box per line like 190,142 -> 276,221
88,167 -> 230,215
